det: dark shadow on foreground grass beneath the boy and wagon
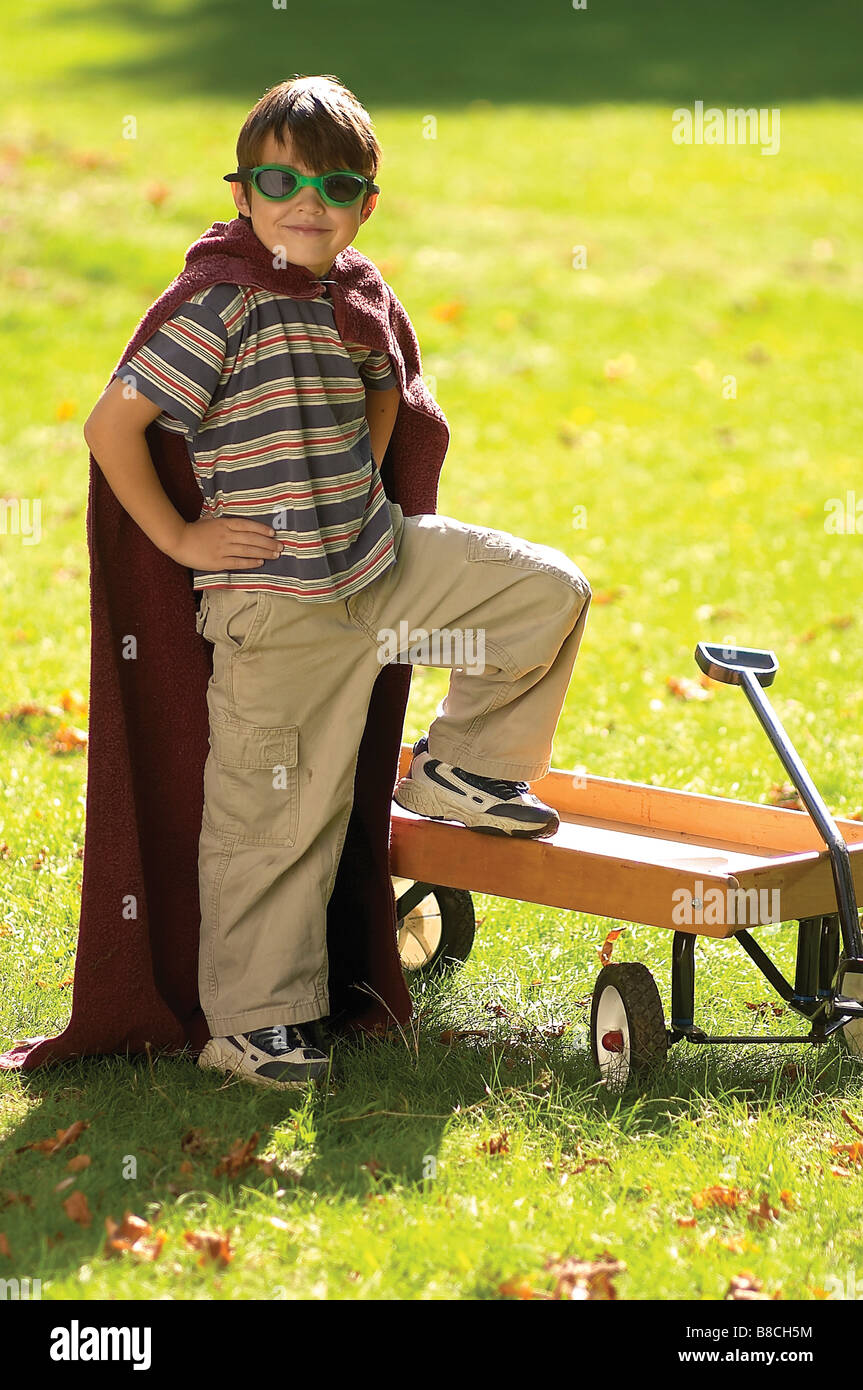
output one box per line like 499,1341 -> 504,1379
0,1000 -> 862,1280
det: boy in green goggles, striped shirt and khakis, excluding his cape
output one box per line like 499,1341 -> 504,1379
85,76 -> 591,1087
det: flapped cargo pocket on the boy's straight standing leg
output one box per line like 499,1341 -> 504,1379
204,719 -> 300,847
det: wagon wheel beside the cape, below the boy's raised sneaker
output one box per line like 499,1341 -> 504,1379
392,877 -> 477,980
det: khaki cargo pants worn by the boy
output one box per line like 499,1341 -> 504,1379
197,502 -> 591,1037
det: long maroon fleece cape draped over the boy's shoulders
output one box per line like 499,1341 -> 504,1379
0,217 -> 449,1070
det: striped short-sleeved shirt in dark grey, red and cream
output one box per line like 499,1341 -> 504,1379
114,284 -> 397,603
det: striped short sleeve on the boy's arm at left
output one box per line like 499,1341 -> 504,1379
114,300 -> 228,432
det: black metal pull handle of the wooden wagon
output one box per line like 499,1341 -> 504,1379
695,642 -> 863,972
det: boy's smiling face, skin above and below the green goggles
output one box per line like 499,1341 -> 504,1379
231,131 -> 378,275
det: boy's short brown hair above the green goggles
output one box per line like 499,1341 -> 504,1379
236,72 -> 381,221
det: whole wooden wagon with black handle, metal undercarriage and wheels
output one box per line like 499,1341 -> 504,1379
391,642 -> 863,1086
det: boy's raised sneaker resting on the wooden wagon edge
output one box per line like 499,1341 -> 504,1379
393,734 -> 560,840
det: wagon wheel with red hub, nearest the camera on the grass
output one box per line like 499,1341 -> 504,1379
591,962 -> 668,1090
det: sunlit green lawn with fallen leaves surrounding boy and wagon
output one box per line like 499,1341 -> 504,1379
0,0 -> 863,1300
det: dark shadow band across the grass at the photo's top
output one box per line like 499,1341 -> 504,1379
45,0 -> 863,113
